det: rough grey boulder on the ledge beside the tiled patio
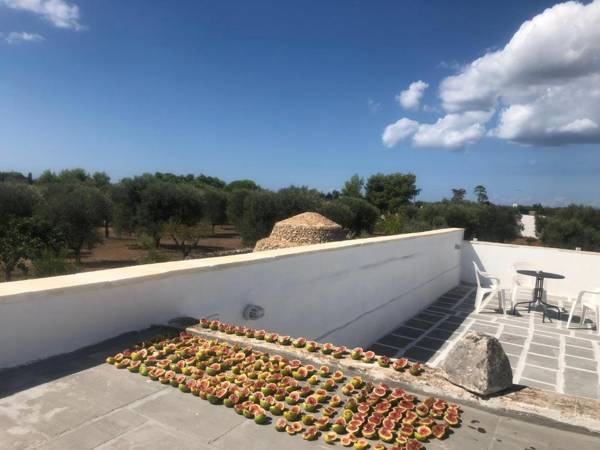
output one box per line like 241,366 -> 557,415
442,331 -> 512,396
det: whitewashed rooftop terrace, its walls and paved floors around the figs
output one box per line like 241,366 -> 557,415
0,229 -> 600,450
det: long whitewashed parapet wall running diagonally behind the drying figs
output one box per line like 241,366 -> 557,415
0,229 -> 463,368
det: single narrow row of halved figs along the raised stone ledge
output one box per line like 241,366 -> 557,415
200,318 -> 423,375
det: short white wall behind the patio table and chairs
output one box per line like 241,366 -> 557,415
461,241 -> 600,297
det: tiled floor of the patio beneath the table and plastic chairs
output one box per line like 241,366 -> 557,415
372,285 -> 600,398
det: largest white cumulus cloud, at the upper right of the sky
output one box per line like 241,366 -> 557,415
383,0 -> 600,149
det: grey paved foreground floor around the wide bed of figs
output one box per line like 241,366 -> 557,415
0,330 -> 600,450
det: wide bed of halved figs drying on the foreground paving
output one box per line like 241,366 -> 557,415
107,333 -> 460,450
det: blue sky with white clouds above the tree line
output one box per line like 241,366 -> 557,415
0,0 -> 600,206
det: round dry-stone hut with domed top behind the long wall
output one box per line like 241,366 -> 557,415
254,212 -> 345,252
